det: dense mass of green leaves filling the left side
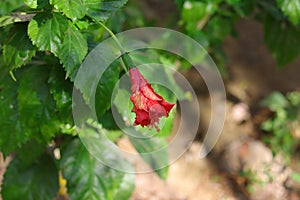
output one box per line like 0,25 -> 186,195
0,0 -> 144,199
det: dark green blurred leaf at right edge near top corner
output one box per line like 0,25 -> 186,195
264,18 -> 300,66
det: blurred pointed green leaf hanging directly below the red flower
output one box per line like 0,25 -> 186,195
129,137 -> 169,179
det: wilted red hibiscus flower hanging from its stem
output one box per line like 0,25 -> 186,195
129,67 -> 175,131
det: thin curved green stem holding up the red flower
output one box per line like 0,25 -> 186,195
94,19 -> 135,72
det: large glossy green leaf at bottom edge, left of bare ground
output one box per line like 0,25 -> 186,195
61,138 -> 134,200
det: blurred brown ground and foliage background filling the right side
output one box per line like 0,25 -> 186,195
120,0 -> 300,200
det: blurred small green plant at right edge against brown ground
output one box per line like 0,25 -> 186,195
262,91 -> 300,161
